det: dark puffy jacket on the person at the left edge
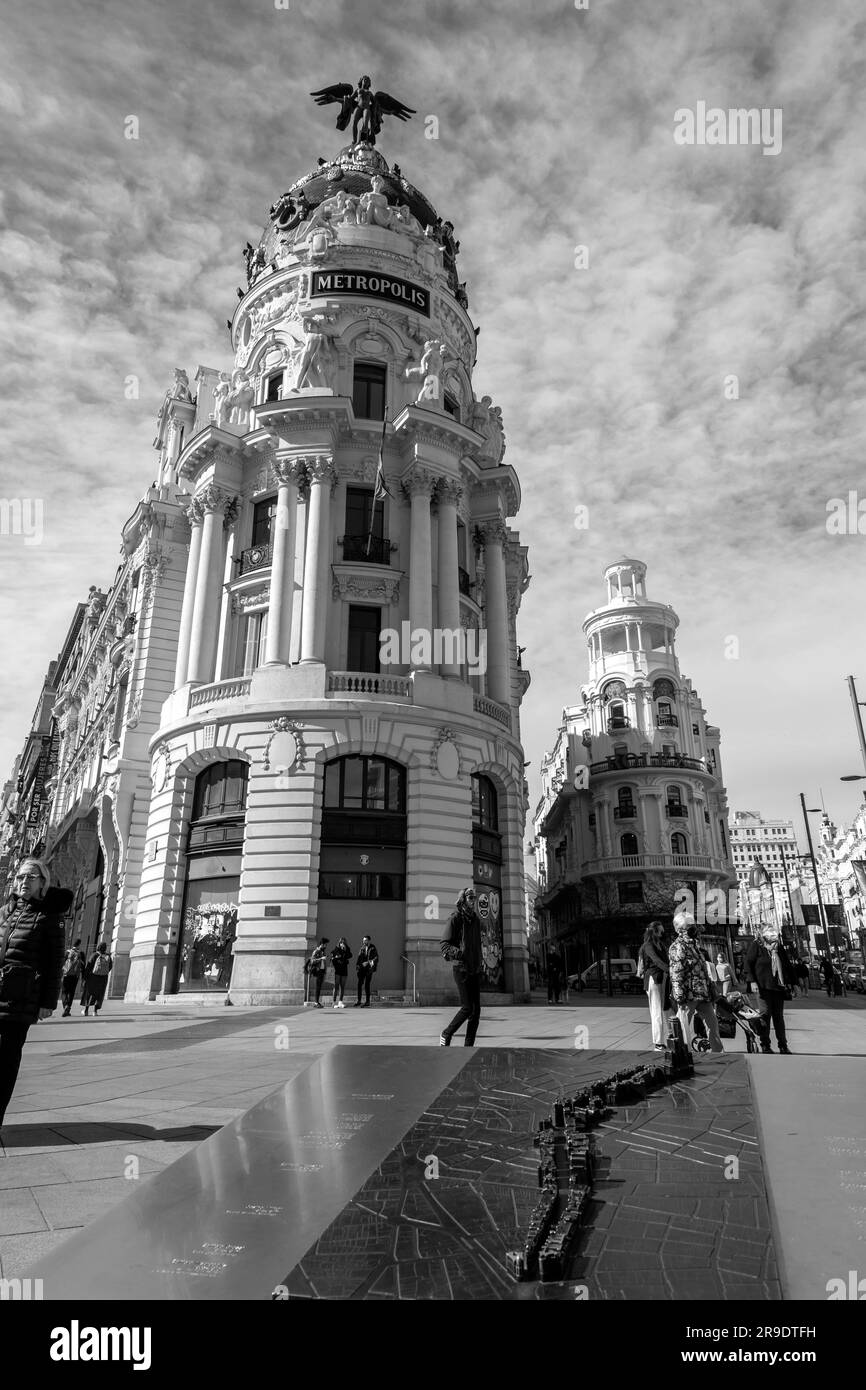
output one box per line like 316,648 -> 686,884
0,888 -> 72,1024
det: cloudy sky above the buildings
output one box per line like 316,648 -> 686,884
0,0 -> 866,839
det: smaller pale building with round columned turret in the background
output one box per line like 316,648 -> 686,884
535,559 -> 737,970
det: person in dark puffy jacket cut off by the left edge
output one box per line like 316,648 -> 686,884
0,859 -> 72,1125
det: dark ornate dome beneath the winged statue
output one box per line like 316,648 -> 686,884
259,145 -> 457,289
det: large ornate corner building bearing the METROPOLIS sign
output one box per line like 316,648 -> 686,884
126,132 -> 530,1004
